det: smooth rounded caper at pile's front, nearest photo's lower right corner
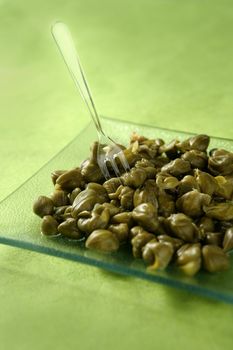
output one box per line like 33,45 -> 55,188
202,245 -> 230,272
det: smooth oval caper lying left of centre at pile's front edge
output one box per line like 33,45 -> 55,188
85,230 -> 120,252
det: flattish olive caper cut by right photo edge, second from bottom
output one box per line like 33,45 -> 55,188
203,202 -> 233,220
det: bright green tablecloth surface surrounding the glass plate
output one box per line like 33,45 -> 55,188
0,0 -> 233,350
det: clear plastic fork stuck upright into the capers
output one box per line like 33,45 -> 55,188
51,22 -> 130,180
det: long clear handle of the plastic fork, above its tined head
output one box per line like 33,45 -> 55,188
51,22 -> 103,134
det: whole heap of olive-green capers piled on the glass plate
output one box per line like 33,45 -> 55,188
33,133 -> 233,276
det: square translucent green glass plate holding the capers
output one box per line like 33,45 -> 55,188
0,118 -> 233,303
